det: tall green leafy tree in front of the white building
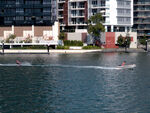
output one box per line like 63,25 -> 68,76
87,13 -> 105,44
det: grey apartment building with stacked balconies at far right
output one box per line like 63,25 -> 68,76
134,0 -> 150,38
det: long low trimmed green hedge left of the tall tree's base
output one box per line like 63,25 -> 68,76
64,40 -> 83,46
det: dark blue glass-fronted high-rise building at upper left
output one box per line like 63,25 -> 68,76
0,0 -> 56,26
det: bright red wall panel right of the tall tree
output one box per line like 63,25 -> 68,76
105,32 -> 118,48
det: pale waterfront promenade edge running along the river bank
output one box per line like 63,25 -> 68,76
0,49 -> 146,54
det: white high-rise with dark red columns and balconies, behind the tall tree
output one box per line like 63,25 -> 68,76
57,0 -> 133,32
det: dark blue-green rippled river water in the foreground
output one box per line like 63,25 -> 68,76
0,53 -> 150,113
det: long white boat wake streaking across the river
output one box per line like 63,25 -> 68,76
0,62 -> 136,70
